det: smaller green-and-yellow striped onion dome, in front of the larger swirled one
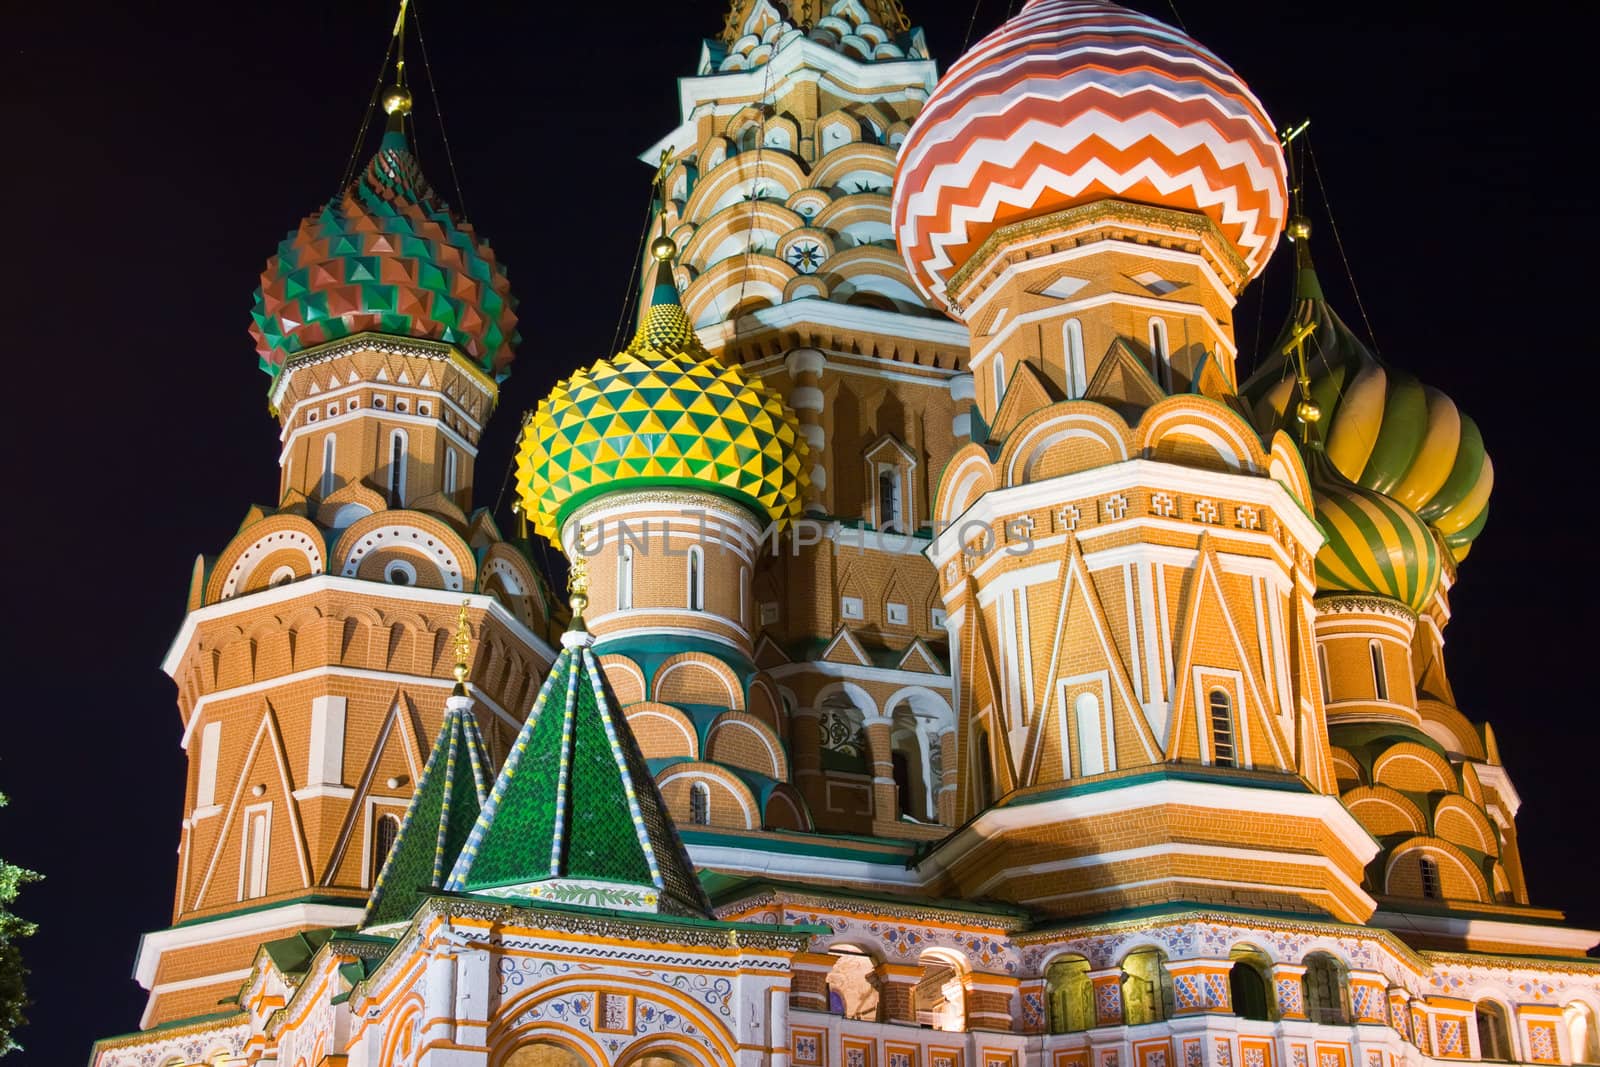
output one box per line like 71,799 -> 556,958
1304,443 -> 1440,611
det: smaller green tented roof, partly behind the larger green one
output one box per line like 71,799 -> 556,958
362,694 -> 491,926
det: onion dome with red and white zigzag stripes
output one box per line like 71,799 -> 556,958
894,0 -> 1286,308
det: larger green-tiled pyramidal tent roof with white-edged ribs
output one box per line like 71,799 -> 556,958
445,632 -> 710,917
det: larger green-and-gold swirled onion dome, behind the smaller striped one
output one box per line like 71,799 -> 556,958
1240,227 -> 1494,561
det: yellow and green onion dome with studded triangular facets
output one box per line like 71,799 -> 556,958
517,237 -> 808,542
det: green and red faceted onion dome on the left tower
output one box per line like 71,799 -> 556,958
250,130 -> 518,379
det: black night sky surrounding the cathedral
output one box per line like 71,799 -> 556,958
0,0 -> 1600,1064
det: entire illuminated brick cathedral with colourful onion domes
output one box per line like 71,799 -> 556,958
94,0 -> 1600,1067
